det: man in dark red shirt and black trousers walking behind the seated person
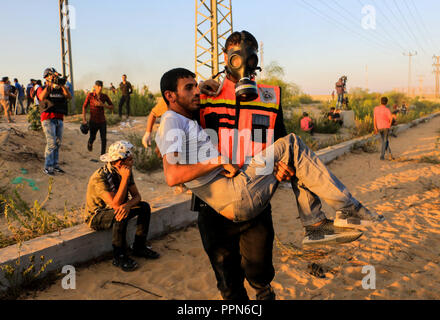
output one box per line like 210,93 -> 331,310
83,80 -> 113,154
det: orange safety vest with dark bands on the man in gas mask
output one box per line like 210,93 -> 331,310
200,79 -> 281,167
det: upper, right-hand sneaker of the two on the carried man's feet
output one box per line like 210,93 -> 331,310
335,204 -> 385,229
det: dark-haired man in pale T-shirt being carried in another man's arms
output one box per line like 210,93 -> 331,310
156,68 -> 384,238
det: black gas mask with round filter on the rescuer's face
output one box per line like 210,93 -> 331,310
226,31 -> 261,102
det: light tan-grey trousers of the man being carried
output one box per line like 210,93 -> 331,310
191,134 -> 359,225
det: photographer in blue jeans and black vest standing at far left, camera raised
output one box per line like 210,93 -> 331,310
37,68 -> 71,176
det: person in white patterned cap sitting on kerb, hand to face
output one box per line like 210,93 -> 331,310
86,141 -> 159,271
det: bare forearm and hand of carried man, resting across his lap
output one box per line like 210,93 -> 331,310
163,152 -> 239,187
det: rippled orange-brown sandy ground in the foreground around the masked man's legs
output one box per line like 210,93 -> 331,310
19,118 -> 440,300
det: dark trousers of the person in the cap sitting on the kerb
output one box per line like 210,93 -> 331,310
90,201 -> 151,253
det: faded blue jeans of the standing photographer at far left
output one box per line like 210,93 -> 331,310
42,119 -> 63,169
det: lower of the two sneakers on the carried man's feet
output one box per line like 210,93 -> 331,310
302,219 -> 363,246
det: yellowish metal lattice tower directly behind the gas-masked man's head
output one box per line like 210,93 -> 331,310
195,0 -> 232,80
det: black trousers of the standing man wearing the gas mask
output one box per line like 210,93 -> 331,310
198,205 -> 275,300
